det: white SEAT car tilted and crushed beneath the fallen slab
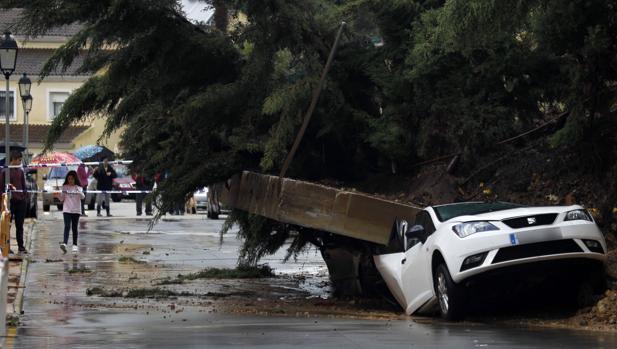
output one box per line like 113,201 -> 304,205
373,202 -> 607,320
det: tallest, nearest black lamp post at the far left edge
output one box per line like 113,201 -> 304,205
0,31 -> 17,196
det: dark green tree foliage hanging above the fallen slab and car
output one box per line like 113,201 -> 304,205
7,0 -> 617,265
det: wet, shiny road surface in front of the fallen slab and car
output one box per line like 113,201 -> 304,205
6,204 -> 617,349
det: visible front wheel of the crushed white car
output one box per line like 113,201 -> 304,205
433,263 -> 465,321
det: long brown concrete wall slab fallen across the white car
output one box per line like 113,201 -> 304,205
215,171 -> 421,245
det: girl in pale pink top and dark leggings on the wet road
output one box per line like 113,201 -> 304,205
60,171 -> 86,253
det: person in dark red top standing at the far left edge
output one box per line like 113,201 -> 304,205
0,149 -> 28,254
